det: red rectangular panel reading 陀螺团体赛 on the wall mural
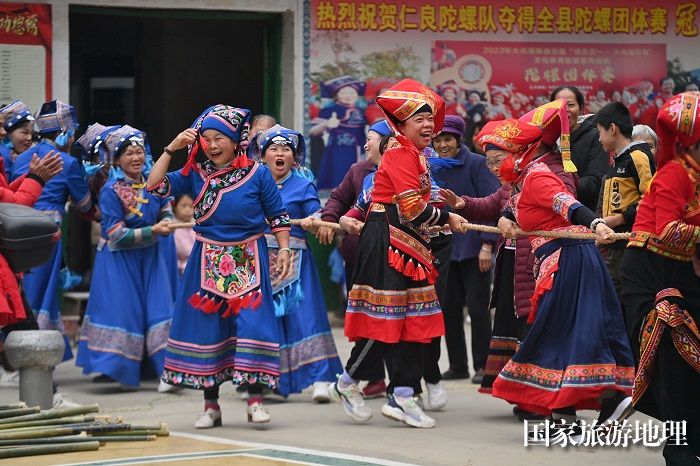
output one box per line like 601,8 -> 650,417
430,41 -> 666,110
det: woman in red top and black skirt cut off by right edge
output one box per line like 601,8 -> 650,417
621,92 -> 700,465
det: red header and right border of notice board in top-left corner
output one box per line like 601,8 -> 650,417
0,3 -> 52,101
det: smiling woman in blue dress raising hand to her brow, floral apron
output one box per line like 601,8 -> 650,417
148,105 -> 291,429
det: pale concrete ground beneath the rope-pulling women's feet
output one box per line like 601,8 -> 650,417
0,327 -> 663,466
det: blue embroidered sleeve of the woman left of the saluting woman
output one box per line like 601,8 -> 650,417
100,185 -> 158,251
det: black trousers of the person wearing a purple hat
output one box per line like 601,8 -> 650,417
442,258 -> 493,372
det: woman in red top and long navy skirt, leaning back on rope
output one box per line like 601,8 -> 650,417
480,99 -> 634,441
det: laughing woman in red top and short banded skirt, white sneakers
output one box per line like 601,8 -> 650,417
330,79 -> 467,428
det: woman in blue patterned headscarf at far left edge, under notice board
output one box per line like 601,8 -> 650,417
0,100 -> 34,181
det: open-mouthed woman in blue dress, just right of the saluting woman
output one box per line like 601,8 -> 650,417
253,125 -> 343,403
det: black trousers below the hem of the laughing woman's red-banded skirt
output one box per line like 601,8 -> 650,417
345,339 -> 425,390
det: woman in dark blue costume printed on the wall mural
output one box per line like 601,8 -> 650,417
310,76 -> 366,189
